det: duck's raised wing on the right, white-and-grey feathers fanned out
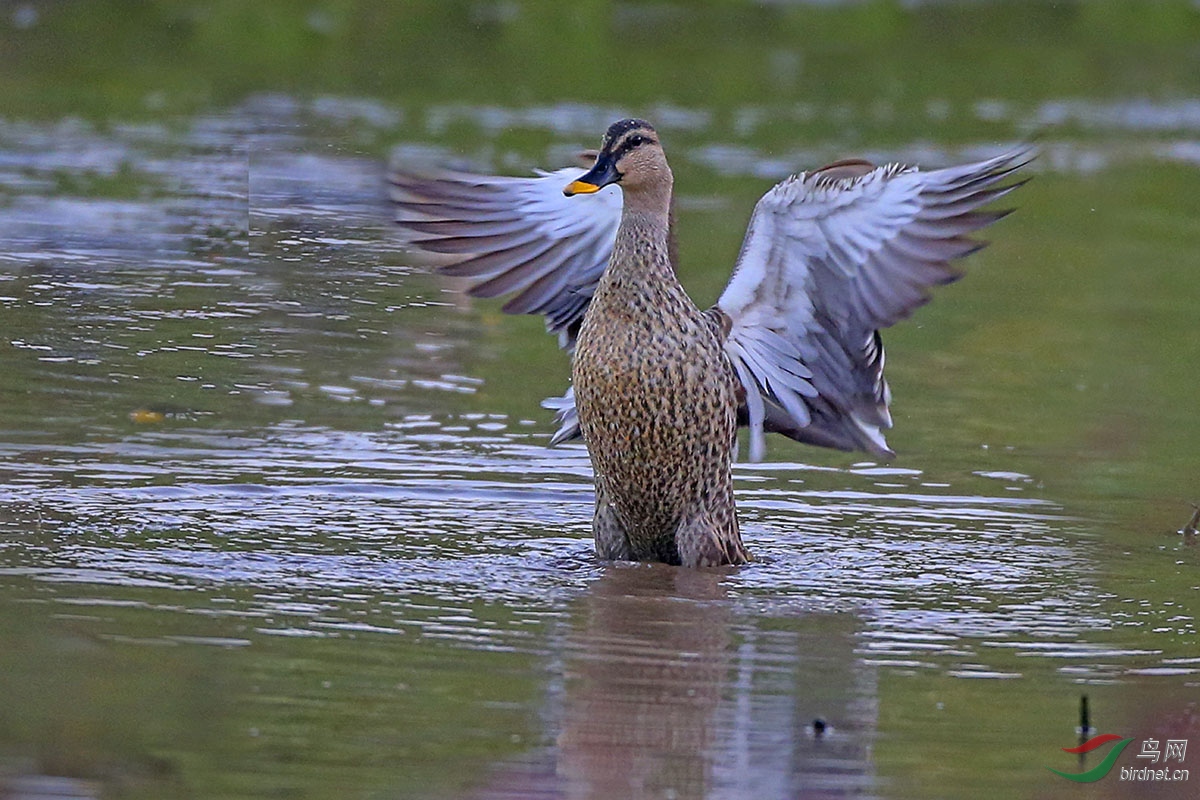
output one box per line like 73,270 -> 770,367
716,149 -> 1033,461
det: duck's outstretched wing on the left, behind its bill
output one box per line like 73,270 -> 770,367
390,168 -> 620,350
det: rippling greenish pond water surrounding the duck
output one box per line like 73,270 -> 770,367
0,4 -> 1200,799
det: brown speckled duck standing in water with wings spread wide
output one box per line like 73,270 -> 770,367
390,119 -> 1036,567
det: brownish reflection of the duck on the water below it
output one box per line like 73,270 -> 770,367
460,565 -> 876,800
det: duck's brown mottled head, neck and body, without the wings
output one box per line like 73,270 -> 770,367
566,120 -> 749,566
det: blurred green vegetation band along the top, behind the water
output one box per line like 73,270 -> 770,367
7,0 -> 1200,144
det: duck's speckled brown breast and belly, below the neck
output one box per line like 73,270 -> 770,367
574,291 -> 737,547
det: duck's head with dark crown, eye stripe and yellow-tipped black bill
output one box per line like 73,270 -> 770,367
563,120 -> 671,197
